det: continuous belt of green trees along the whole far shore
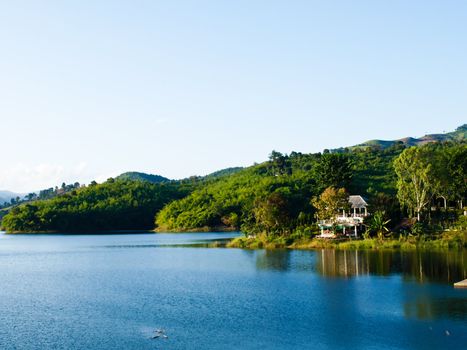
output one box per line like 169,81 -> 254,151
2,142 -> 467,235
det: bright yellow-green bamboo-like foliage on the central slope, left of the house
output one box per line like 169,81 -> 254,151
157,165 -> 313,234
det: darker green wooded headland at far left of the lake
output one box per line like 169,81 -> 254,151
2,179 -> 187,232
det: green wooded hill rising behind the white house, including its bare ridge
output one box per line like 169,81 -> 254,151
156,125 -> 467,234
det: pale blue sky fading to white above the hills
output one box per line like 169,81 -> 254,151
0,0 -> 467,192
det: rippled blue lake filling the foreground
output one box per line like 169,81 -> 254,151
0,233 -> 467,349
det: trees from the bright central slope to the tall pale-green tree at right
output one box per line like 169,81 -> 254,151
156,143 -> 467,235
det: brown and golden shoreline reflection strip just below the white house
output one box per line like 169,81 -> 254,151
252,249 -> 467,284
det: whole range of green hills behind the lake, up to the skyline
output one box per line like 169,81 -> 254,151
2,125 -> 467,235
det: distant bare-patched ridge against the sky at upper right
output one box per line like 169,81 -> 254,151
337,124 -> 467,150
